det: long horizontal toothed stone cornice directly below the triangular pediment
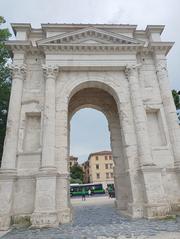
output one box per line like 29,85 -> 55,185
6,41 -> 174,55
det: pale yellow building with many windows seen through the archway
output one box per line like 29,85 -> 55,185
83,151 -> 114,189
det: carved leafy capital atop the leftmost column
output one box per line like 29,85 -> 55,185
8,64 -> 27,79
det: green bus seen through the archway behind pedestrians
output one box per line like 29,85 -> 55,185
70,183 -> 105,197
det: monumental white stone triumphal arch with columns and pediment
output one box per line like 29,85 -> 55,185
0,23 -> 180,229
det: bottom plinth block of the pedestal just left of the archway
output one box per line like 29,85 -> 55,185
31,212 -> 59,228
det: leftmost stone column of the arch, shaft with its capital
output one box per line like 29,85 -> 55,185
1,64 -> 26,170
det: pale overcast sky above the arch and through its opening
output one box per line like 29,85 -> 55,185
0,0 -> 180,162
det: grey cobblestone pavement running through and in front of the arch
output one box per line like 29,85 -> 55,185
2,197 -> 180,239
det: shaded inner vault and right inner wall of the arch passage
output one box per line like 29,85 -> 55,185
68,82 -> 132,213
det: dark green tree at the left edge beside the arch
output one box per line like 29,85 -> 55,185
0,16 -> 11,163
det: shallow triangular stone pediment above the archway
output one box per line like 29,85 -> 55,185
37,27 -> 144,46
